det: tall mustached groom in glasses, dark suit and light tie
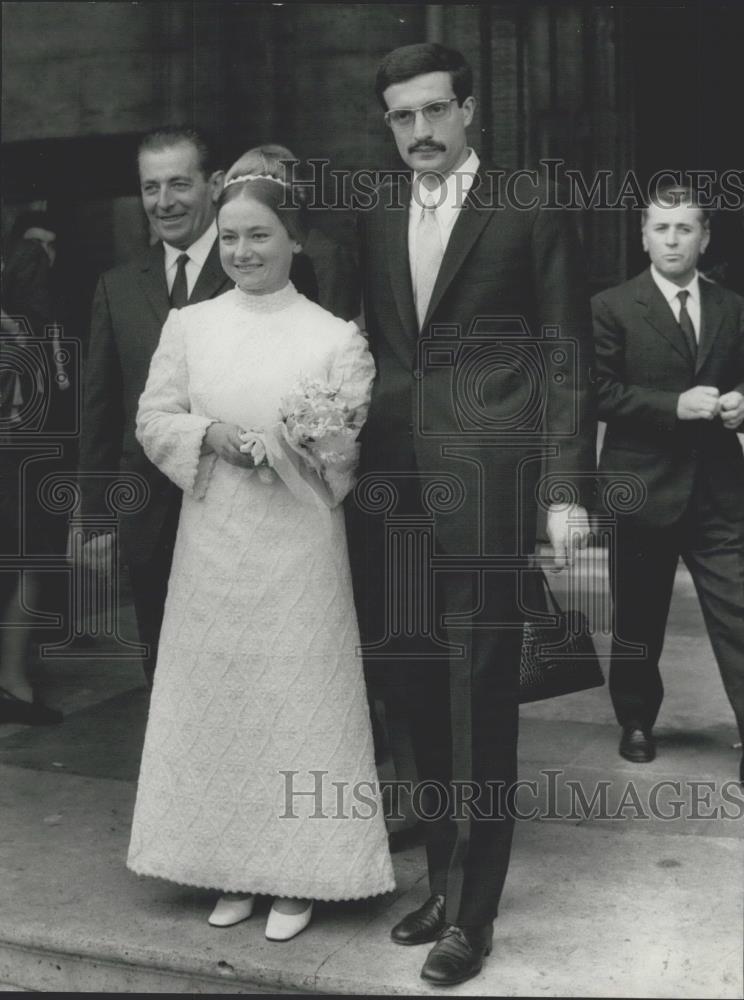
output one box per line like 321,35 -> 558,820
348,44 -> 596,986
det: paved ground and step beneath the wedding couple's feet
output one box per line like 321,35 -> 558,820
0,560 -> 744,998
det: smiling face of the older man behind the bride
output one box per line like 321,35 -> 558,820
139,141 -> 222,250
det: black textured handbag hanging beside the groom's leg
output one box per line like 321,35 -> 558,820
519,571 -> 605,705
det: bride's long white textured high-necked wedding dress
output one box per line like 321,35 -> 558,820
127,284 -> 395,900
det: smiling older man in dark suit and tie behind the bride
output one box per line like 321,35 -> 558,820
80,127 -> 231,684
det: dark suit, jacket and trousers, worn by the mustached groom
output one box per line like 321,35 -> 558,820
349,165 -> 596,926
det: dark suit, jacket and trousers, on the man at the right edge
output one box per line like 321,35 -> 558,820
592,269 -> 744,737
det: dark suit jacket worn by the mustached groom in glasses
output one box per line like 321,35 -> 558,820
361,164 -> 596,553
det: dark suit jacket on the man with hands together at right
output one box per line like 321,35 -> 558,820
592,269 -> 744,525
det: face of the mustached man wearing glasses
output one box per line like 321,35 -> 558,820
383,72 -> 475,177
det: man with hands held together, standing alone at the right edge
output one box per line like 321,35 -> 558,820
592,187 -> 744,779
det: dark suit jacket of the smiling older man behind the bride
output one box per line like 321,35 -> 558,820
80,240 -> 232,562
